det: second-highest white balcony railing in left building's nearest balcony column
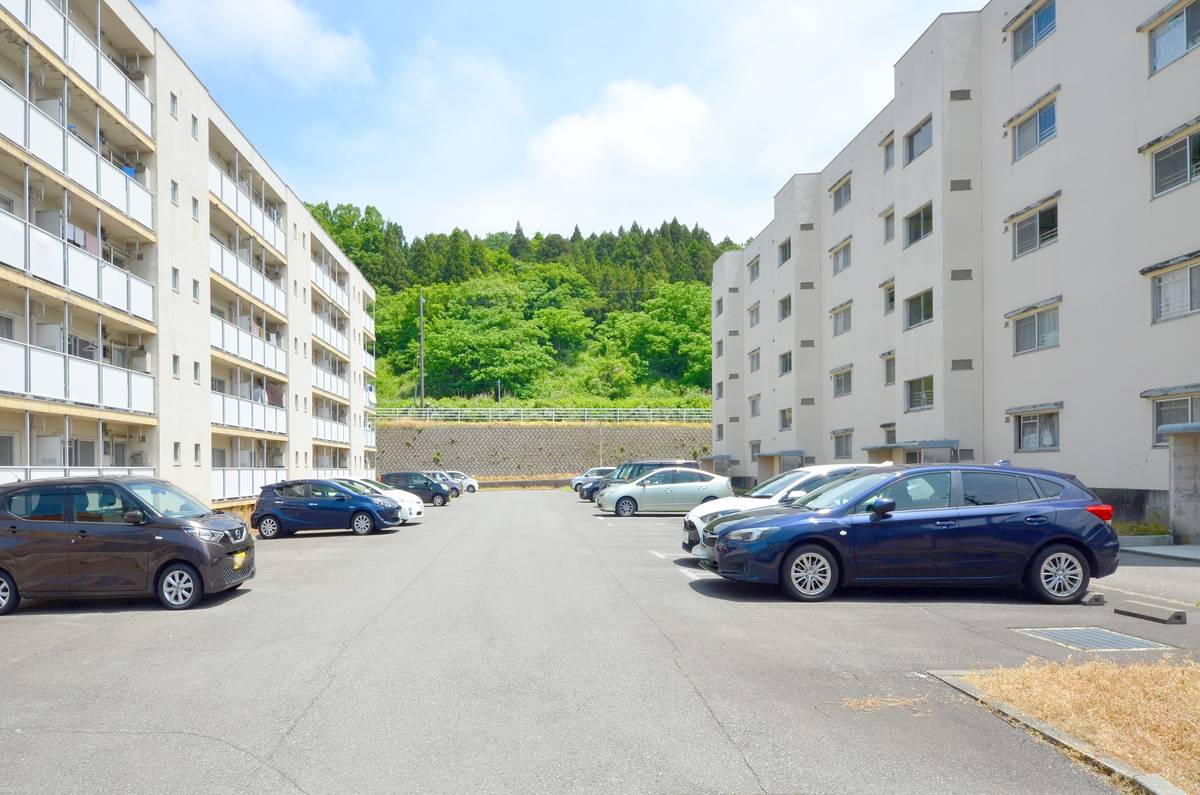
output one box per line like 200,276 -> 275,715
0,83 -> 154,229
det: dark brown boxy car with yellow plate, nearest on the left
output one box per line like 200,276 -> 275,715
0,478 -> 254,615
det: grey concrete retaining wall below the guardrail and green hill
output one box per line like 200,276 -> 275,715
378,422 -> 713,477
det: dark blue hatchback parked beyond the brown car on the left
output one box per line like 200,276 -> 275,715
250,480 -> 401,539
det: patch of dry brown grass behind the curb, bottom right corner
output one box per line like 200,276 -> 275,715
967,657 -> 1200,793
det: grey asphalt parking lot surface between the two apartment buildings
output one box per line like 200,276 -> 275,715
0,491 -> 1200,793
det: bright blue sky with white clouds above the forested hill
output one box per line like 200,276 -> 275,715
139,0 -> 982,241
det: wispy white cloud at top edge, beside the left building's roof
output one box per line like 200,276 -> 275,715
144,0 -> 372,89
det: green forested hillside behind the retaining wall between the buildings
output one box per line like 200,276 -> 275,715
308,203 -> 737,407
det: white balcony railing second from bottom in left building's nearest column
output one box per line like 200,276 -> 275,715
0,340 -> 154,414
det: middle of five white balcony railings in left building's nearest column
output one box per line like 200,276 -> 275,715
0,210 -> 154,321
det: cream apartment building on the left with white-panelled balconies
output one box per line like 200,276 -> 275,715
0,0 -> 376,504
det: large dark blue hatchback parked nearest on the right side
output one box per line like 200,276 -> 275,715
702,465 -> 1117,604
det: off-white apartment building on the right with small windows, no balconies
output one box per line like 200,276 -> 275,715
713,0 -> 1200,504
